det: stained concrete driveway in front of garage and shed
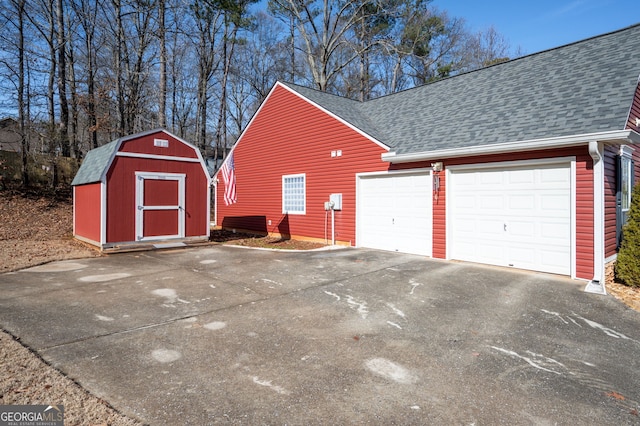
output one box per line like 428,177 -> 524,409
0,246 -> 640,425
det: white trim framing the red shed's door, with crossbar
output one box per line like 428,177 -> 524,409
136,172 -> 186,241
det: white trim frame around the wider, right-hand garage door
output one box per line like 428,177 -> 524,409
445,156 -> 576,279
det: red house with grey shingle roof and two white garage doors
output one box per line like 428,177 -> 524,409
215,25 -> 640,288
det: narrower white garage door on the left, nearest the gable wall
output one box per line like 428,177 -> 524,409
357,173 -> 432,256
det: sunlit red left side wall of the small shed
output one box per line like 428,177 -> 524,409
73,182 -> 102,243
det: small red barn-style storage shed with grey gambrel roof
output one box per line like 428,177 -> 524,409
72,129 -> 211,250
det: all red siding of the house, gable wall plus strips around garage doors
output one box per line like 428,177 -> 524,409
216,85 -> 610,279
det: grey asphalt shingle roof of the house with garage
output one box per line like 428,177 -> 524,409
288,24 -> 640,154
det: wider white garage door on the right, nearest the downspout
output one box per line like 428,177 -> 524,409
447,164 -> 572,275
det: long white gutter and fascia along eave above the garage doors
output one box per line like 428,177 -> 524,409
381,130 -> 640,163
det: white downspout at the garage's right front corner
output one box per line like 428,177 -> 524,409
584,141 -> 607,295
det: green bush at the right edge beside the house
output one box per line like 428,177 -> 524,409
616,184 -> 640,287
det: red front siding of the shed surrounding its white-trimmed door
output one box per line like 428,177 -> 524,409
106,156 -> 209,243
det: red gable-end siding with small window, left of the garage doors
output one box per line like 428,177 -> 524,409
217,86 -> 388,245
